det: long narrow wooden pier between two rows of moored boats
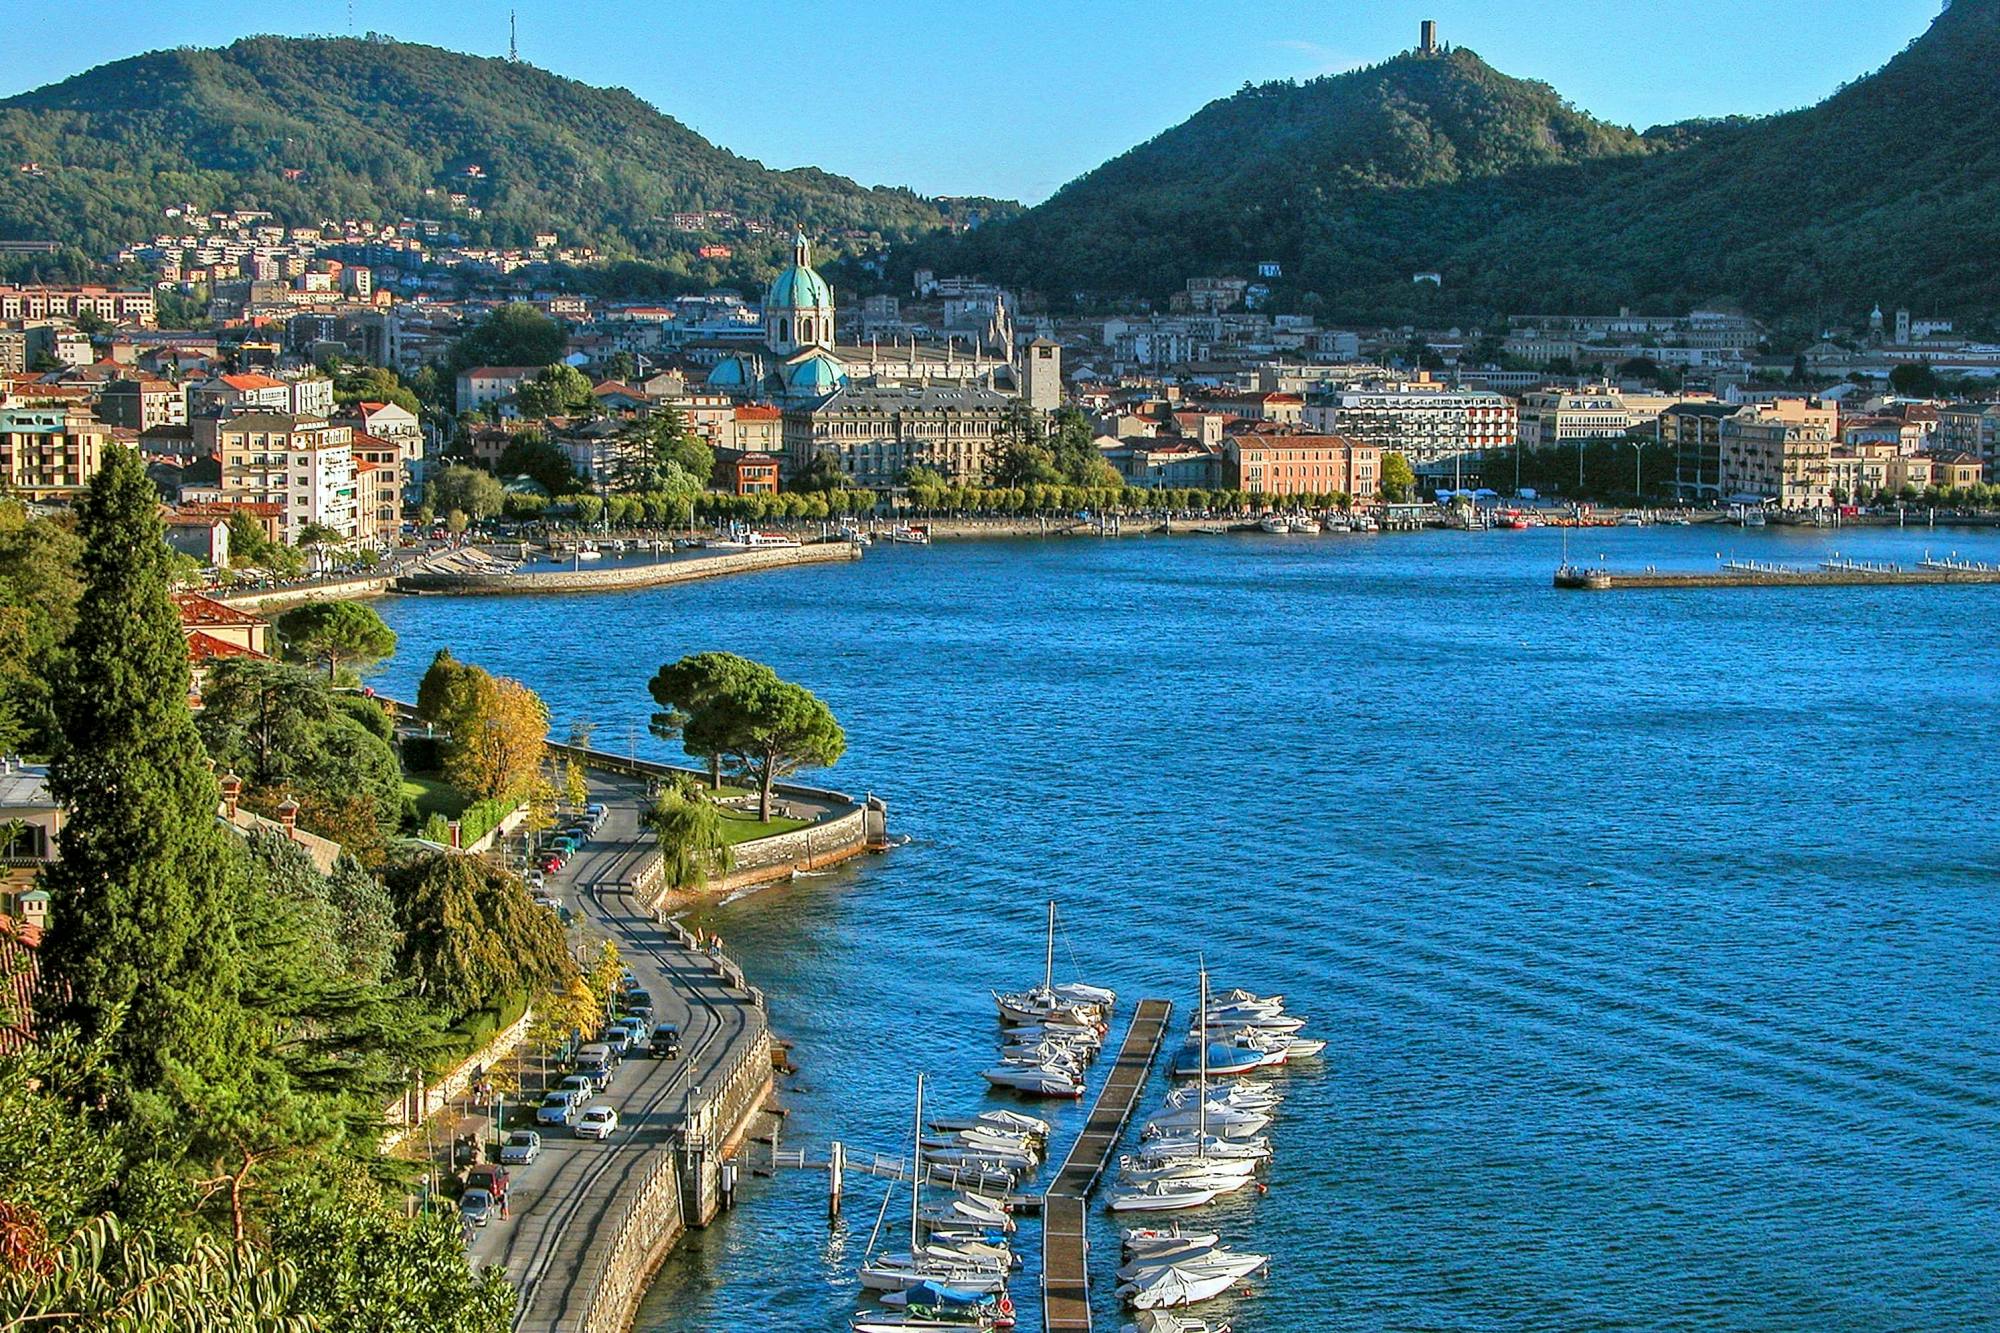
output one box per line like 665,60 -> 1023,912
1042,999 -> 1174,1333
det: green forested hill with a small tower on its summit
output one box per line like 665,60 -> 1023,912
958,48 -> 1650,296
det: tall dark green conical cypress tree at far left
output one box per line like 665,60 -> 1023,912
38,448 -> 238,1119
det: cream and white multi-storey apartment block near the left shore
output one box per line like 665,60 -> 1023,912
214,412 -> 360,542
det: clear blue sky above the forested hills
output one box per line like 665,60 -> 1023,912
0,0 -> 1940,200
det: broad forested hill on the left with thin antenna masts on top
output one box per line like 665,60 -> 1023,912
0,38 -> 976,256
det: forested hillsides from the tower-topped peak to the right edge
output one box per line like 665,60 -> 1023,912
932,0 -> 2000,320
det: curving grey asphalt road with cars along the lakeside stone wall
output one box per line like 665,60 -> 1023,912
470,781 -> 764,1329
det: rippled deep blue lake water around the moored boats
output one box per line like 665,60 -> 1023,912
382,528 -> 2000,1333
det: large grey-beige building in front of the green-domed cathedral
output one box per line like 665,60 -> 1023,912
784,384 -> 1014,490
